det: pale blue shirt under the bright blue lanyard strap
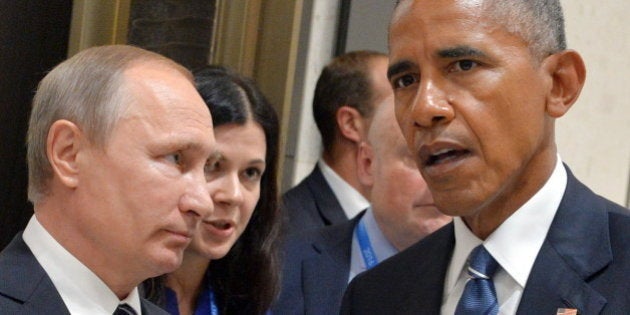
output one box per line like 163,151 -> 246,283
348,207 -> 398,282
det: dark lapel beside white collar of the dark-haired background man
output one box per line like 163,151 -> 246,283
307,166 -> 348,225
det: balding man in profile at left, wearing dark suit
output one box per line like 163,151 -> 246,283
0,46 -> 214,314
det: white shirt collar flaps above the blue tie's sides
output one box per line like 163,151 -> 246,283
445,156 -> 567,292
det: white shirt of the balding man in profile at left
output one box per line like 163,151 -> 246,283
23,216 -> 141,315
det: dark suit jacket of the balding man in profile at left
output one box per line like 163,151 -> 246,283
0,233 -> 168,315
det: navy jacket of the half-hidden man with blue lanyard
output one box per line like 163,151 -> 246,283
272,211 -> 365,315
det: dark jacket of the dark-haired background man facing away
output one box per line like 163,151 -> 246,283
282,165 -> 348,233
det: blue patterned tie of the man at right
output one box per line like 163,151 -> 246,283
455,245 -> 499,315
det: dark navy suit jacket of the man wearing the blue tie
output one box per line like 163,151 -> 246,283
342,169 -> 630,315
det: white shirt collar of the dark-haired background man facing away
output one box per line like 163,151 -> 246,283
317,159 -> 370,219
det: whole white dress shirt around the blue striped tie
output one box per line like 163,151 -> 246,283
441,157 -> 567,315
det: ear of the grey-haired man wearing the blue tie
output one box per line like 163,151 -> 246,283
543,50 -> 586,118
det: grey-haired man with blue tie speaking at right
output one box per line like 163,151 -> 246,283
342,0 -> 630,314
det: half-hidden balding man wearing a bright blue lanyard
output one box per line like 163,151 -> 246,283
273,93 -> 451,314
